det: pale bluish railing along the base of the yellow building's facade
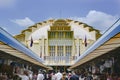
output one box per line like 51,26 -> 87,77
44,56 -> 77,66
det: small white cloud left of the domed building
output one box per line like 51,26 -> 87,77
11,17 -> 34,27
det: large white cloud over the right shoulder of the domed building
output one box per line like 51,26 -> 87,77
70,10 -> 118,33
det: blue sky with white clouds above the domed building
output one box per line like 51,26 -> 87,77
0,0 -> 120,35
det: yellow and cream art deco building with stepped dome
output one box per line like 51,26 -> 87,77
15,19 -> 101,68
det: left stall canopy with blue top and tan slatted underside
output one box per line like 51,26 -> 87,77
0,28 -> 48,68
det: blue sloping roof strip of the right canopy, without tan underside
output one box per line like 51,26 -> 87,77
75,18 -> 120,63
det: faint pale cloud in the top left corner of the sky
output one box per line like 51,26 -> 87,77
0,0 -> 17,8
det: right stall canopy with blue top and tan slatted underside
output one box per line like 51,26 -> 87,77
70,19 -> 120,69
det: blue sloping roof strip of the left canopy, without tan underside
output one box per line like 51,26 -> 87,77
0,27 -> 43,63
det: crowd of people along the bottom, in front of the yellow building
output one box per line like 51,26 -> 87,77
0,69 -> 120,80
